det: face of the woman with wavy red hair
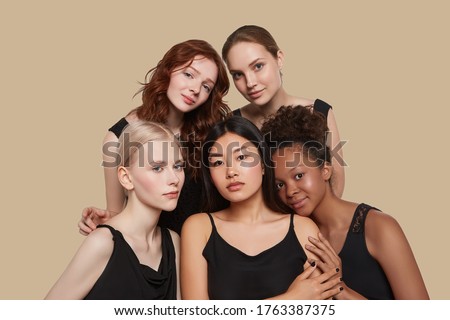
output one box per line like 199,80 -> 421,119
167,56 -> 219,113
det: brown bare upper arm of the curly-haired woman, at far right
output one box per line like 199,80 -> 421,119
366,210 -> 429,300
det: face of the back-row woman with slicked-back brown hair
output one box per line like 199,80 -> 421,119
227,42 -> 282,105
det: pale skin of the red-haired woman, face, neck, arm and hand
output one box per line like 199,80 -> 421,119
78,56 -> 218,235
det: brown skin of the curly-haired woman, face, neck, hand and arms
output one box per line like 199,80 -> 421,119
273,146 -> 429,300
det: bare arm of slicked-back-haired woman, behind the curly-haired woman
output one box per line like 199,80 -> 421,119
327,109 -> 345,198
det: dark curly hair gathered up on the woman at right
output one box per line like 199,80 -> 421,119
261,105 -> 331,165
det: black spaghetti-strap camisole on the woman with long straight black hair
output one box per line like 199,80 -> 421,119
203,214 -> 307,300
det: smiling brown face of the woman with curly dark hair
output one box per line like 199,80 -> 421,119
272,147 -> 329,216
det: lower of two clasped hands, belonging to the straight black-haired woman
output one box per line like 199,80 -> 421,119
285,261 -> 344,300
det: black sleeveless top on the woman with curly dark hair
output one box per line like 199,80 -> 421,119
339,203 -> 394,300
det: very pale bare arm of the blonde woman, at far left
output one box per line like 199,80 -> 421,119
45,229 -> 114,300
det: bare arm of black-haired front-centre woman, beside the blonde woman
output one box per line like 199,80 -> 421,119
180,214 -> 212,300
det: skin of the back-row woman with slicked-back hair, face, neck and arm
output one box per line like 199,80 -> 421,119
226,42 -> 345,198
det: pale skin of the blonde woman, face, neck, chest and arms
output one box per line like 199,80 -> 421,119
45,141 -> 184,300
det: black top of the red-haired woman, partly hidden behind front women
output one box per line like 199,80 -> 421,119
109,118 -> 229,234
